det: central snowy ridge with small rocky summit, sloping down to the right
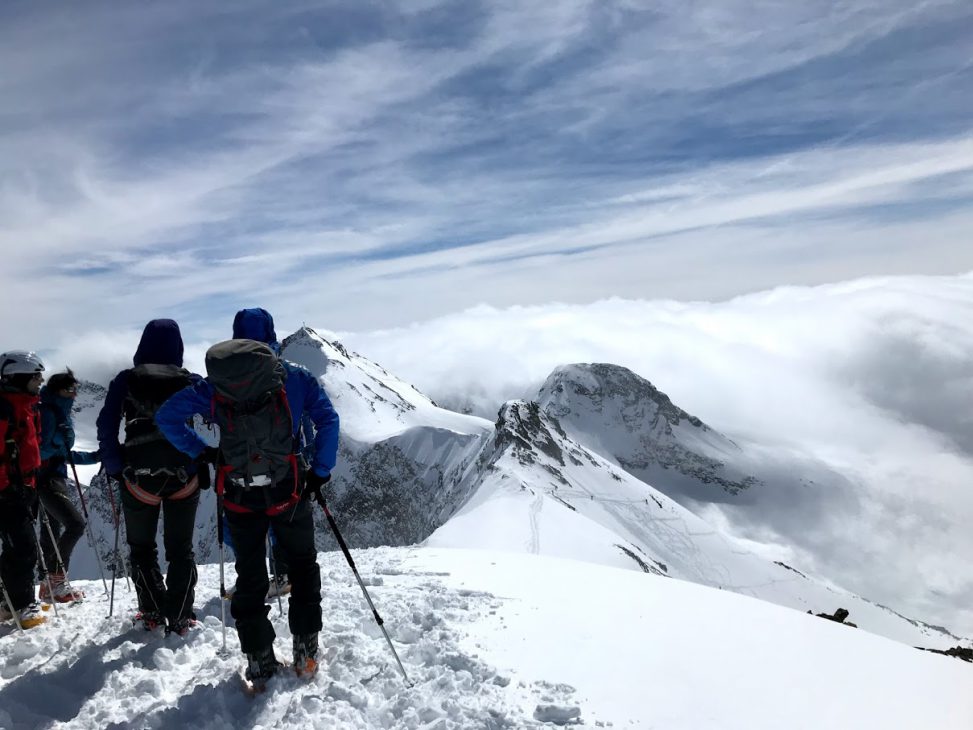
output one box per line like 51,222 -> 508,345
426,401 -> 958,647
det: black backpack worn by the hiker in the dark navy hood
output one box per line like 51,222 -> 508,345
123,364 -> 192,494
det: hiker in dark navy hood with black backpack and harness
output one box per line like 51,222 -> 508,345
97,319 -> 202,635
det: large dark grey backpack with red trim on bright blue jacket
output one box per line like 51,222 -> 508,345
206,339 -> 297,492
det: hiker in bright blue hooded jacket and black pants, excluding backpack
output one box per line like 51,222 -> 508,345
156,309 -> 339,680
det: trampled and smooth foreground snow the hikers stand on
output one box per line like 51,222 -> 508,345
0,548 -> 973,730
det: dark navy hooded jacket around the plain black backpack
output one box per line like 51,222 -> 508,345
97,319 -> 201,475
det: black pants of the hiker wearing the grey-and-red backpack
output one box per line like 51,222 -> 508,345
226,501 -> 321,654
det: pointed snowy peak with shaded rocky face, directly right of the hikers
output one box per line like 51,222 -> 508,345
283,328 -> 493,548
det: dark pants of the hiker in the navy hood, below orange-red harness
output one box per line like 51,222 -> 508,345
121,487 -> 199,623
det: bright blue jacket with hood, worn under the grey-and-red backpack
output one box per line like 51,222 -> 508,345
155,308 -> 339,477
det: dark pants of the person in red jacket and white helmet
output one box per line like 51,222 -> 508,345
0,485 -> 37,611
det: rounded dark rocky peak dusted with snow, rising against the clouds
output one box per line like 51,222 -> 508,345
537,363 -> 759,499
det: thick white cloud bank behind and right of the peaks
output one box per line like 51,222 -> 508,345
344,274 -> 973,635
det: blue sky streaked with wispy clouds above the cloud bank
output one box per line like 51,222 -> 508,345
0,0 -> 973,348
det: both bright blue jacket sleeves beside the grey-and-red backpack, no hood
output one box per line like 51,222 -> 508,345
155,361 -> 338,477
